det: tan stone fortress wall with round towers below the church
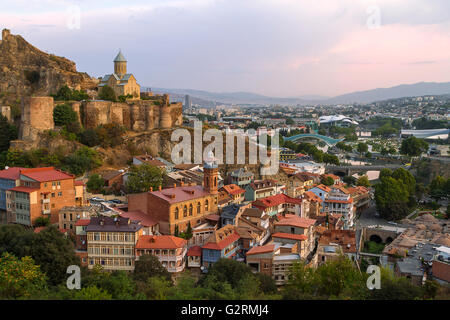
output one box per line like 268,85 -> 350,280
19,94 -> 183,141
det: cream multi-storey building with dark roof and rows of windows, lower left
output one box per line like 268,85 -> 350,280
86,216 -> 142,271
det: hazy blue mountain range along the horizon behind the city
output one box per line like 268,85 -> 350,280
145,82 -> 450,106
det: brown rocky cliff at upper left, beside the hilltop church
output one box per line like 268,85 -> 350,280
0,29 -> 97,105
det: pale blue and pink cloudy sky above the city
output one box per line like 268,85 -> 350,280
0,0 -> 450,97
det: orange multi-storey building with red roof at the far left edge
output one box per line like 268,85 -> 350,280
6,167 -> 84,226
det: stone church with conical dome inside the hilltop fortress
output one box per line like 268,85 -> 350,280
98,50 -> 141,99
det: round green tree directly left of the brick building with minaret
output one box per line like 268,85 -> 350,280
125,163 -> 163,193
